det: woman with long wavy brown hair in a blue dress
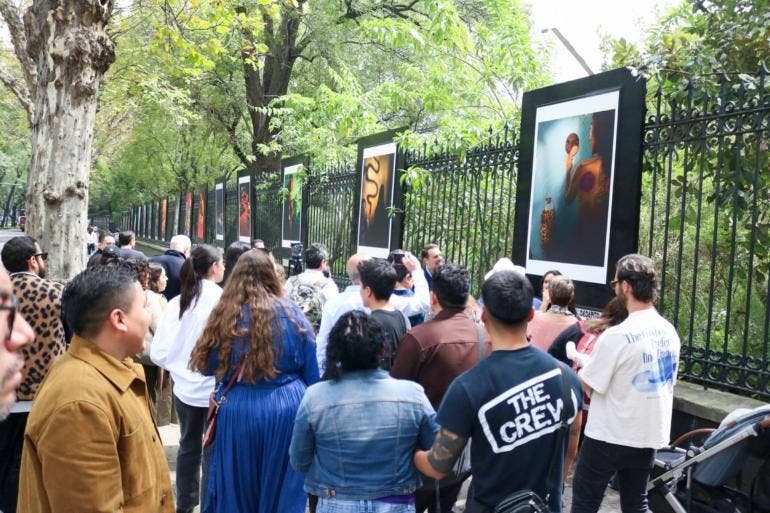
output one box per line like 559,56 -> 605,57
190,250 -> 318,513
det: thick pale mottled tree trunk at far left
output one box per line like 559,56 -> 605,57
24,0 -> 115,280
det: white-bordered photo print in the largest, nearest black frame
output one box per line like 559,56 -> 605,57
526,91 -> 619,283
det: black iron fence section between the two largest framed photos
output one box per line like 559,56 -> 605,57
404,125 -> 518,295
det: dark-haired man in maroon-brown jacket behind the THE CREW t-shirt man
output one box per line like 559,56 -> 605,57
390,264 -> 486,513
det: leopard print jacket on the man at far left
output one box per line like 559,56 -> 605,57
11,273 -> 67,401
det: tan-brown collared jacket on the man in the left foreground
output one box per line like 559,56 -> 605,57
18,336 -> 174,513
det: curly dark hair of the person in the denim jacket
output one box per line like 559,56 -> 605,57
323,310 -> 386,379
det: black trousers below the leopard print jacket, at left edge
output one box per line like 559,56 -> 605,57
0,413 -> 29,513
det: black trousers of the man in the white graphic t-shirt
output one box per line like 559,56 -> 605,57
572,437 -> 655,513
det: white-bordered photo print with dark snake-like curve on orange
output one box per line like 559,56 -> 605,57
358,143 -> 396,258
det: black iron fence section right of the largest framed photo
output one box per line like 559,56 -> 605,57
640,70 -> 770,398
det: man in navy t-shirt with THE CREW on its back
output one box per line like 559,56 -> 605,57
414,271 -> 582,513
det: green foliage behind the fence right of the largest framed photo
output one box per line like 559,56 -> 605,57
620,0 -> 770,392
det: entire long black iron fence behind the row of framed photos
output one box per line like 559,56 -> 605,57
120,69 -> 770,399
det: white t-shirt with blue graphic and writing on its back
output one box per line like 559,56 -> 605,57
580,308 -> 680,449
